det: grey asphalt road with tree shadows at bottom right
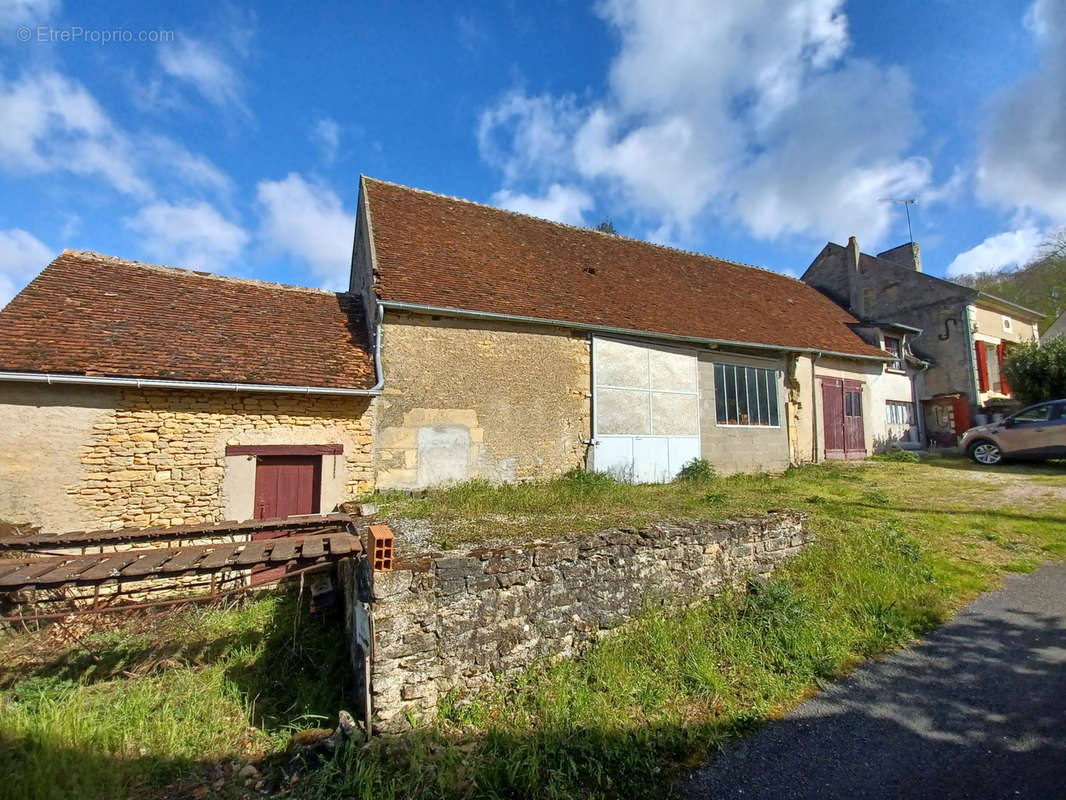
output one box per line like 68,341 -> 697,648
679,564 -> 1066,800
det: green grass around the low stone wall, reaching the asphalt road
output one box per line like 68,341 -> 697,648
0,458 -> 1066,798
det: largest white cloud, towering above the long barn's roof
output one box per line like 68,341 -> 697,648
478,0 -> 932,246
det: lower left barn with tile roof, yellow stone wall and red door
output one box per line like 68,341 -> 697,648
0,251 -> 379,530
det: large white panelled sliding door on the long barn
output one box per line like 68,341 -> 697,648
593,337 -> 699,483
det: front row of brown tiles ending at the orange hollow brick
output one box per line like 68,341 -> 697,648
0,532 -> 362,592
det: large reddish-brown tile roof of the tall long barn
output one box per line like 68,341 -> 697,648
364,178 -> 886,356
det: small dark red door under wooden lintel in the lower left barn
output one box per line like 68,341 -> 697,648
252,455 -> 322,583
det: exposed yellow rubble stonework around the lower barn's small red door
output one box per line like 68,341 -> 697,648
65,390 -> 373,528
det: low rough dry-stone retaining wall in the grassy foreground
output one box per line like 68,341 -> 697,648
358,512 -> 810,730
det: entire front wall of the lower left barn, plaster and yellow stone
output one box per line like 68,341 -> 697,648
0,382 -> 373,531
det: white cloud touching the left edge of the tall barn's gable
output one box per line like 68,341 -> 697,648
256,173 -> 355,289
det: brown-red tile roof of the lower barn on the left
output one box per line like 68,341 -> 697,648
0,250 -> 375,388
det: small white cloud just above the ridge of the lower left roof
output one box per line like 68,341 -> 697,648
124,202 -> 248,272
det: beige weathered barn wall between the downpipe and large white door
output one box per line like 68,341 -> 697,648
375,311 -> 589,489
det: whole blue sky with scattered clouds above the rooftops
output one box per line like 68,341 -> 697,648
0,0 -> 1066,303
